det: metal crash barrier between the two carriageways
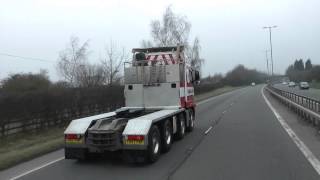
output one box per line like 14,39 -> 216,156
265,85 -> 320,130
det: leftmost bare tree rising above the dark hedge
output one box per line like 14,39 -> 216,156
57,36 -> 89,86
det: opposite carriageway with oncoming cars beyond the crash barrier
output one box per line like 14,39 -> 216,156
275,84 -> 320,100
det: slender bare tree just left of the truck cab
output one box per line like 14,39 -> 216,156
101,41 -> 128,85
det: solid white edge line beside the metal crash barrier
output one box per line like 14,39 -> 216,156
261,87 -> 320,175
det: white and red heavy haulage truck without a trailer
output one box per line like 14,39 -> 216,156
64,46 -> 199,162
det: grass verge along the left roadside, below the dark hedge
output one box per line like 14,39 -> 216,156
0,86 -> 240,170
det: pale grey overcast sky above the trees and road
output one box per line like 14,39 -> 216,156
0,0 -> 320,80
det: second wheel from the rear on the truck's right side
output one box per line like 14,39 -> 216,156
161,120 -> 172,152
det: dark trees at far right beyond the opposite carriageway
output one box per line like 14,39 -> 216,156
286,59 -> 320,82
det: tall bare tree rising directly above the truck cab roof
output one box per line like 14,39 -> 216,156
151,6 -> 191,46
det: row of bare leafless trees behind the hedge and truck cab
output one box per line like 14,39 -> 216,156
56,6 -> 204,87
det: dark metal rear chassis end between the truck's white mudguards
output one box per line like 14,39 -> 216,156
88,131 -> 118,148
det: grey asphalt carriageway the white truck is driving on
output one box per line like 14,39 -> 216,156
0,86 -> 320,180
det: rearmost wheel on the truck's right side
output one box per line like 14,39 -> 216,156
146,125 -> 161,163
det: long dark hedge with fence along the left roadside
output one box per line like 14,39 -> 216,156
0,83 -> 223,137
